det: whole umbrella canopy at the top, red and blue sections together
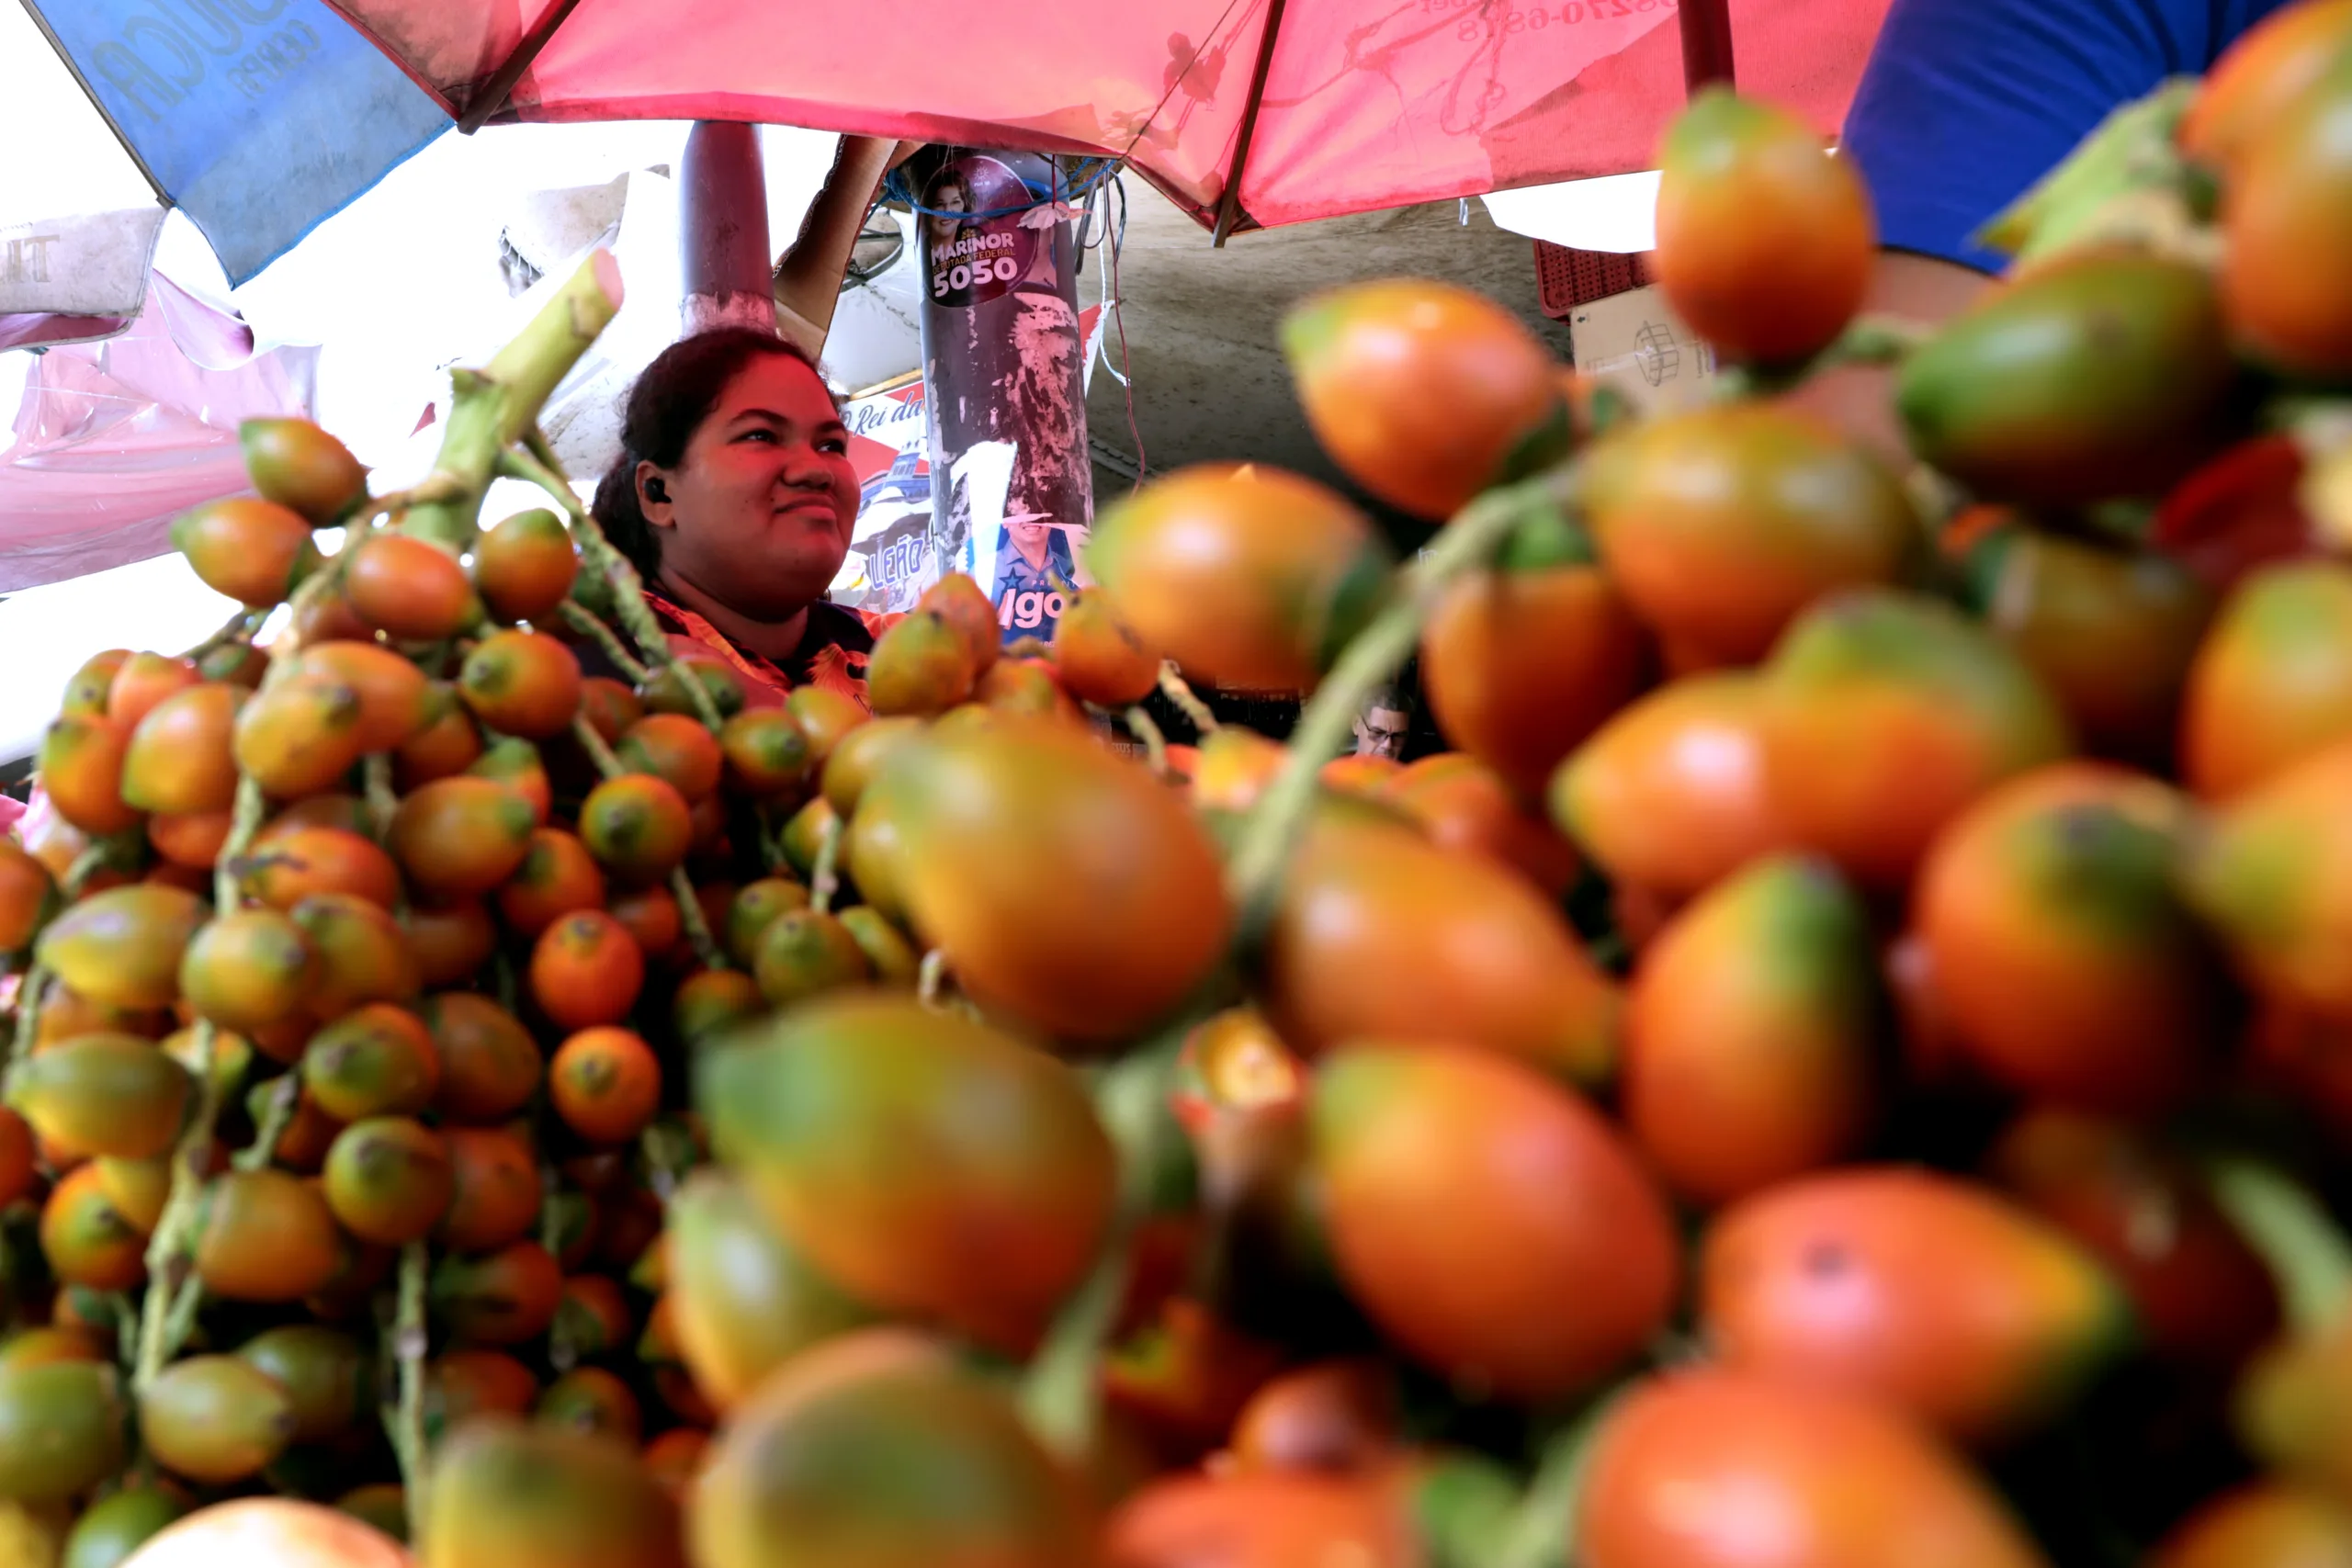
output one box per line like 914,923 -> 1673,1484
14,0 -> 1886,299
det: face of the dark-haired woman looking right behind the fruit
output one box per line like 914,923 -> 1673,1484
638,355 -> 858,621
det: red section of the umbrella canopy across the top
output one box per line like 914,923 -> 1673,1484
334,0 -> 1886,228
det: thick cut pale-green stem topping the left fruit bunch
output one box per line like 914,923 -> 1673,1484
400,249 -> 621,555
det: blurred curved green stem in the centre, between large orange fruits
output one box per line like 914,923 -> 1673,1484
1226,466 -> 1576,941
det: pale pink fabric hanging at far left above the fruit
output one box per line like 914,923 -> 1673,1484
0,275 -> 318,592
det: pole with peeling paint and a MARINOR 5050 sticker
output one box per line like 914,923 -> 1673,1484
917,148 -> 1093,642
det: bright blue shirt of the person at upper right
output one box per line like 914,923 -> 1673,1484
1841,0 -> 2281,273
